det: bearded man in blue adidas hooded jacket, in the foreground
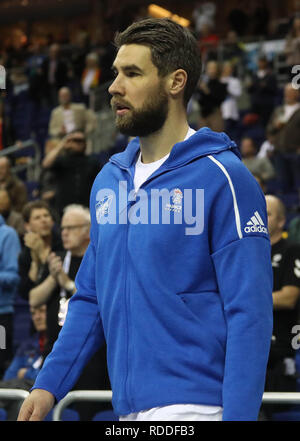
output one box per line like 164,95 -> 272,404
18,19 -> 272,421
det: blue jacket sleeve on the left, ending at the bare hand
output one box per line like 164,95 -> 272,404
32,243 -> 104,401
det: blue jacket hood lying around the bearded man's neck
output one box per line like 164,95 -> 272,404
110,127 -> 241,168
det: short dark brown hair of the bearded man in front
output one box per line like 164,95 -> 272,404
115,18 -> 201,105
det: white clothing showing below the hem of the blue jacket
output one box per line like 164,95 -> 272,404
119,404 -> 223,421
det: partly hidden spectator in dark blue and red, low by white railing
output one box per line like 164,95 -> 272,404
0,305 -> 47,421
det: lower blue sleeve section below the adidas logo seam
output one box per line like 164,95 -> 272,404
212,237 -> 273,421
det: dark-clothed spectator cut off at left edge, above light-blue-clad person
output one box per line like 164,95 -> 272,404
0,156 -> 28,212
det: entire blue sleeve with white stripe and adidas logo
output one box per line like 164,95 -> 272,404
211,155 -> 273,421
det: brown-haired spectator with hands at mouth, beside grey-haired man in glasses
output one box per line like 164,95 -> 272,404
19,200 -> 62,300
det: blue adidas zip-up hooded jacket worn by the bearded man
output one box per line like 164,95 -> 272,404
34,128 -> 273,420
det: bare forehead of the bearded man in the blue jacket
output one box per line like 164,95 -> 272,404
113,44 -> 154,69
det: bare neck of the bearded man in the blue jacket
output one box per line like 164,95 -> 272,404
140,110 -> 189,164
